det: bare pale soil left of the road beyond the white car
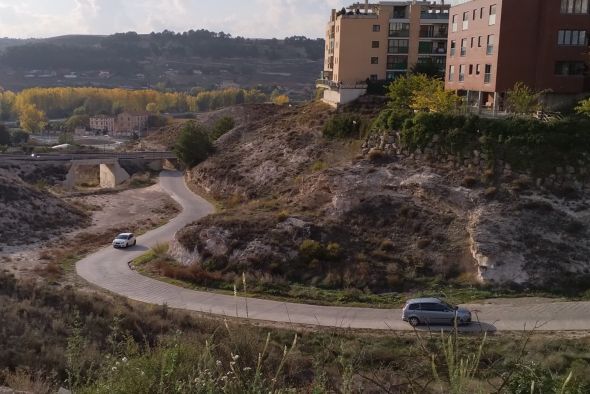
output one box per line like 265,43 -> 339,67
0,184 -> 180,282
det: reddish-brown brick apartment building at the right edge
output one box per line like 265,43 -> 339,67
445,0 -> 590,112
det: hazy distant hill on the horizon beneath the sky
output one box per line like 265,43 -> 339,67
0,30 -> 324,95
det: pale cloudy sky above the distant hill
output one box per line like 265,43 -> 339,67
0,0 -> 464,38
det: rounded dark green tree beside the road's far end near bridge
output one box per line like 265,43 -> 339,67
174,122 -> 213,168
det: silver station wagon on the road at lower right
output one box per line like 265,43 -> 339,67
402,298 -> 471,327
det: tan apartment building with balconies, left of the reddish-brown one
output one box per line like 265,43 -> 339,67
317,0 -> 450,105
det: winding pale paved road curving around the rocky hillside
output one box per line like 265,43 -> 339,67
76,172 -> 590,331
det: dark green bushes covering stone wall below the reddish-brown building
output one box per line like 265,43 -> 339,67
401,113 -> 590,174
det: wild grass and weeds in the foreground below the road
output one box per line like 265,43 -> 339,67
0,266 -> 590,394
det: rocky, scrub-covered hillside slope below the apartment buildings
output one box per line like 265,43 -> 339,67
166,104 -> 590,293
